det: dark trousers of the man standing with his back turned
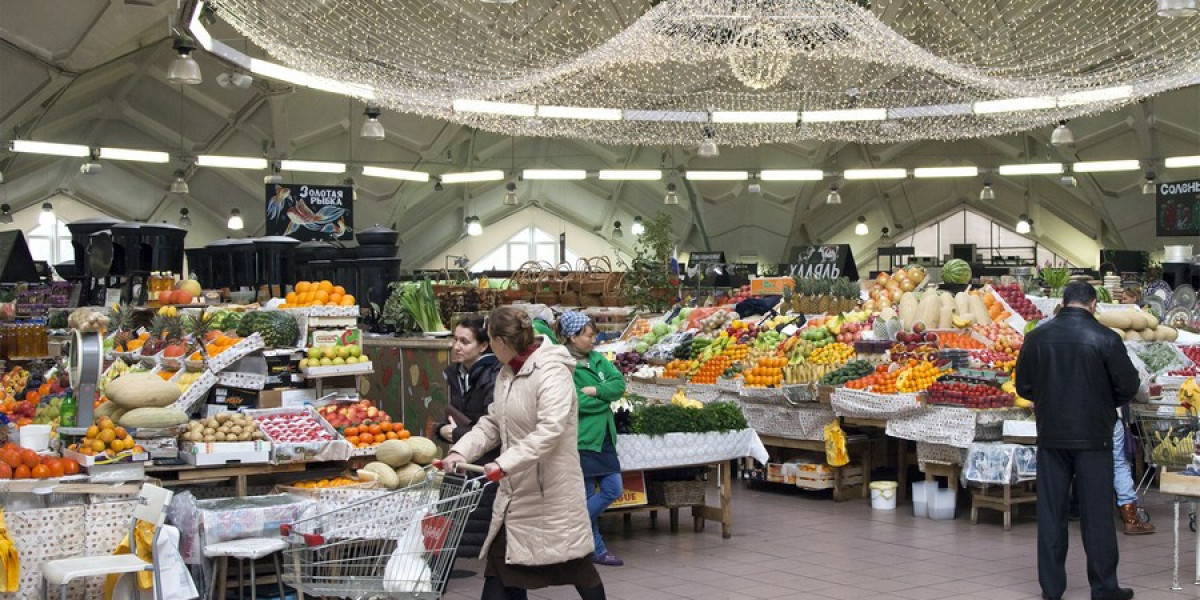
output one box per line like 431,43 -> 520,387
1038,448 -> 1118,598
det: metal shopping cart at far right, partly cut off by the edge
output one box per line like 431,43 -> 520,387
1132,404 -> 1200,532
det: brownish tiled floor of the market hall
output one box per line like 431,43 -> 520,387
445,482 -> 1200,600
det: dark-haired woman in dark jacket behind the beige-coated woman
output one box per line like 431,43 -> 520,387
438,316 -> 503,557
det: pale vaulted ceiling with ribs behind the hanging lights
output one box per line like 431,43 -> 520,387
0,0 -> 1200,270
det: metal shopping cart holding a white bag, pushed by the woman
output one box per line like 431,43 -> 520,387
280,464 -> 498,600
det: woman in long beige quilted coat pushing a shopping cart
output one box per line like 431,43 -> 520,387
444,306 -> 605,600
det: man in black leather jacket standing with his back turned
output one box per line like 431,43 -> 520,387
1016,282 -> 1139,600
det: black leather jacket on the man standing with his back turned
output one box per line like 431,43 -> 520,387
1016,307 -> 1140,450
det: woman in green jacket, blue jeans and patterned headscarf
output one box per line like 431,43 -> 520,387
558,311 -> 625,566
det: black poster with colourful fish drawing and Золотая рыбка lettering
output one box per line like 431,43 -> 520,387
266,184 -> 354,241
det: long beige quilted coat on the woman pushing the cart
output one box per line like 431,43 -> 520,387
452,343 -> 594,565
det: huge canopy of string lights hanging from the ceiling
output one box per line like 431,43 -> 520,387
215,0 -> 1200,145
